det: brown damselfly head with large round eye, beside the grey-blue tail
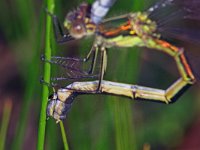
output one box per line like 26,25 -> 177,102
64,3 -> 96,39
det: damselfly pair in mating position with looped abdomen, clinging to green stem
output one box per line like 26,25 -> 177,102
43,0 -> 200,121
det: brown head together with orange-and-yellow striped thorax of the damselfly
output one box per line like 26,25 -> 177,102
64,3 -> 159,47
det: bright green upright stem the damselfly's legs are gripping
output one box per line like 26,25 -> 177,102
37,0 -> 54,150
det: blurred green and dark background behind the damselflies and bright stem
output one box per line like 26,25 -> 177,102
0,0 -> 200,150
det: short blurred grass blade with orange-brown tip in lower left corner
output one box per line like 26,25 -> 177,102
0,99 -> 12,150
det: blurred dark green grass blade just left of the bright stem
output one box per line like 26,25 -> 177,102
11,3 -> 44,150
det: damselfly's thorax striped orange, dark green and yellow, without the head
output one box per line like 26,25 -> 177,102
95,12 -> 159,48
